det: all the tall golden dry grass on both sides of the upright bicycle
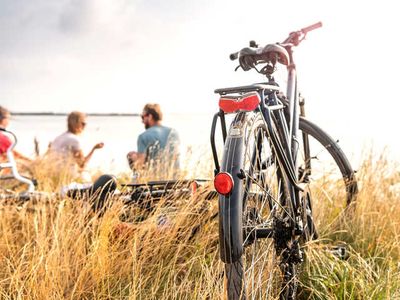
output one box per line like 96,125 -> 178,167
0,157 -> 400,299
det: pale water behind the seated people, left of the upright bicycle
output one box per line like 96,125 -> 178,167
8,114 -> 217,173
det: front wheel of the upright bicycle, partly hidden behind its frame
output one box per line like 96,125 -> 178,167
299,117 -> 358,238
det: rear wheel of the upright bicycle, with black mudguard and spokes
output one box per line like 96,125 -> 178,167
219,113 -> 299,299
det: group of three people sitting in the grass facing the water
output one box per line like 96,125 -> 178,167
0,104 -> 179,211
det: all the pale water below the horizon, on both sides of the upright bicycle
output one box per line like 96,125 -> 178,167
5,114 -> 400,176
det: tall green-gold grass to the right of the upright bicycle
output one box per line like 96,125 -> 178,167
301,154 -> 400,299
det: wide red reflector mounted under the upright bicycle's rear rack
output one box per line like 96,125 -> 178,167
219,92 -> 261,113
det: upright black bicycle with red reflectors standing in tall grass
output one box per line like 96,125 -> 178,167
211,23 -> 358,299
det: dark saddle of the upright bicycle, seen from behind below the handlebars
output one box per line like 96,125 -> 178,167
239,44 -> 290,71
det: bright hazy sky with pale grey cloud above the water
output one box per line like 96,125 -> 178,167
0,0 -> 400,158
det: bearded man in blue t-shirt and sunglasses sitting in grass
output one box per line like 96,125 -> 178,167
127,104 -> 179,169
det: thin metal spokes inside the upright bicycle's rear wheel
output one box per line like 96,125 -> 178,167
223,114 -> 294,299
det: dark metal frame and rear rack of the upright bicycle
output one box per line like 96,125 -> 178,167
210,53 -> 302,217
